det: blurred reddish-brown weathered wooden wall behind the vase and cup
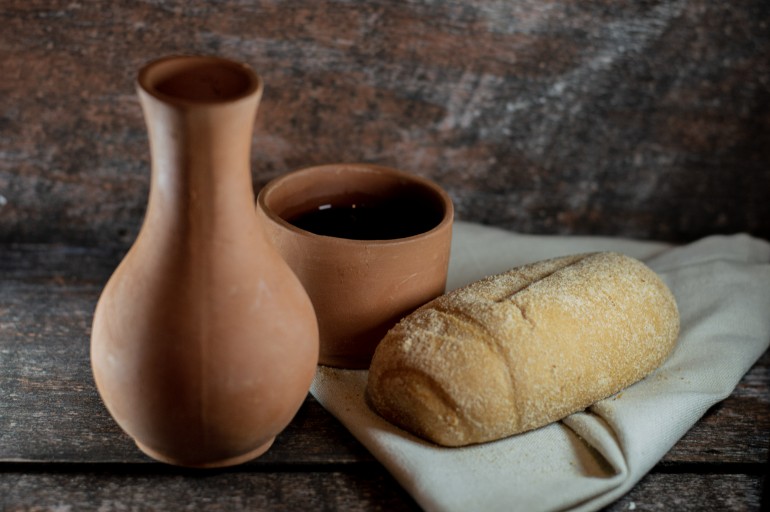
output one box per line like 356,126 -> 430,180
0,0 -> 770,245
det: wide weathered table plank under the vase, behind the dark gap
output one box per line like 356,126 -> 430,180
0,246 -> 770,465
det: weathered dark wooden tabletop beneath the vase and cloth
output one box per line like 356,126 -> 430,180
0,244 -> 770,511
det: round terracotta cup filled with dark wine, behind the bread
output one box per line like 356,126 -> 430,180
257,164 -> 454,368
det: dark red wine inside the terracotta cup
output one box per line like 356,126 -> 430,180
286,197 -> 443,240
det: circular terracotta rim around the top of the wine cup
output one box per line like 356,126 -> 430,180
256,163 -> 454,246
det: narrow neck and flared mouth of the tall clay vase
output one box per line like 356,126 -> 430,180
137,56 -> 263,227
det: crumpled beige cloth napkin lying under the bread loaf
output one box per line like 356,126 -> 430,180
311,223 -> 770,511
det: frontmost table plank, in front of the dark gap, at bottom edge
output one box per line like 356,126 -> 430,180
0,464 -> 767,512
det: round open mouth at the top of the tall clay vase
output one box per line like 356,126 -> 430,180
137,55 -> 262,105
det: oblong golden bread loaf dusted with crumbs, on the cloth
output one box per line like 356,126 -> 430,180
366,252 -> 679,446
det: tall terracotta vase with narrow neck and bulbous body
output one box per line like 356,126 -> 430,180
91,56 -> 318,467
